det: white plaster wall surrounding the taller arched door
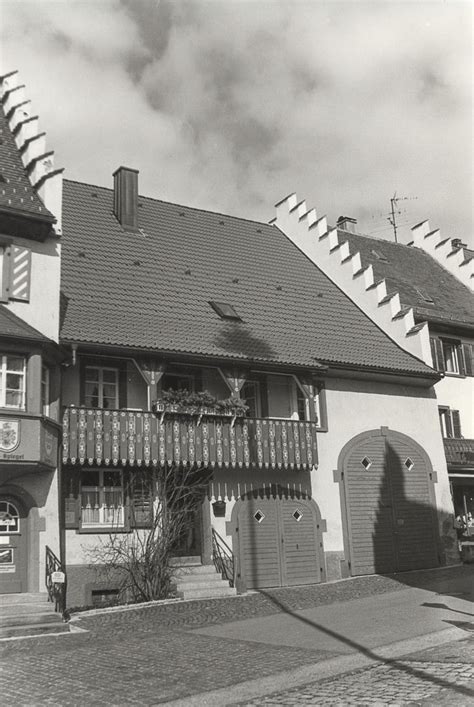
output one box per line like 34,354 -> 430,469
312,379 -> 452,551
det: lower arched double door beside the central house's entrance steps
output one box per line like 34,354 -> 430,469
233,490 -> 324,589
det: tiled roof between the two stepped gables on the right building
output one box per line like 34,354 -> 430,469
338,231 -> 474,326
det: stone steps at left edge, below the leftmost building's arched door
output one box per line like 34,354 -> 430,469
0,593 -> 69,639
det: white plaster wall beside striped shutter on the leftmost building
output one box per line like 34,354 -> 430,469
8,238 -> 61,341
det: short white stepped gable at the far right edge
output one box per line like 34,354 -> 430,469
411,221 -> 474,292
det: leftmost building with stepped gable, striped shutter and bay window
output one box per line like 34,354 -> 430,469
0,74 -> 61,593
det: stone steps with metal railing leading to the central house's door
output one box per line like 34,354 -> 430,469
173,557 -> 237,599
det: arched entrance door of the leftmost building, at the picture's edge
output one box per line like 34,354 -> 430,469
0,497 -> 28,594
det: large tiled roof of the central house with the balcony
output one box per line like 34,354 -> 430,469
61,180 -> 433,375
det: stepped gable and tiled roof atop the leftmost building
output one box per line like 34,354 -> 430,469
0,71 -> 63,240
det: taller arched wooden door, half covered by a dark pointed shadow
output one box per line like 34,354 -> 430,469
343,432 -> 438,575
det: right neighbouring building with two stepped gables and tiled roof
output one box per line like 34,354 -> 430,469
277,195 -> 474,538
